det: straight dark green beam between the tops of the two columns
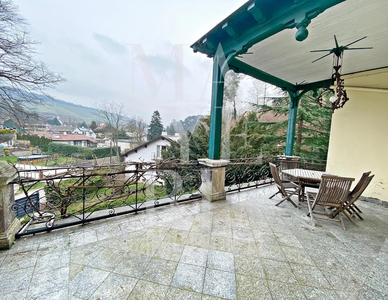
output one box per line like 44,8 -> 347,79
229,59 -> 297,91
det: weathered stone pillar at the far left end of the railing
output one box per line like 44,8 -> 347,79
0,161 -> 20,249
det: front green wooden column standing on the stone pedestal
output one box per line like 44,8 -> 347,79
209,55 -> 224,159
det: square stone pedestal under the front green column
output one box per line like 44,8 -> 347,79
198,158 -> 229,202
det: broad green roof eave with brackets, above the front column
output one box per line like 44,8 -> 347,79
191,0 -> 345,57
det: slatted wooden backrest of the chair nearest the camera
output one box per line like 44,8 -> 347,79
316,175 -> 354,206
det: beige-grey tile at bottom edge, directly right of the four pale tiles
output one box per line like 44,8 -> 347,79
236,274 -> 272,300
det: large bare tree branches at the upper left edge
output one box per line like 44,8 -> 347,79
0,0 -> 64,126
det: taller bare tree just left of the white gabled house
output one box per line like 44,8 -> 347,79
94,100 -> 125,161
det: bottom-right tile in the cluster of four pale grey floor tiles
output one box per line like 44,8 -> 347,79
203,268 -> 236,299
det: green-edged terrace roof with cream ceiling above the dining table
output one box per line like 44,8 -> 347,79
191,0 -> 388,91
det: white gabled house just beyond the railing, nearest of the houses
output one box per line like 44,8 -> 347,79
121,135 -> 180,162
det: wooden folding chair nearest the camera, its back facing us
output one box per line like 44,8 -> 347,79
306,175 -> 354,230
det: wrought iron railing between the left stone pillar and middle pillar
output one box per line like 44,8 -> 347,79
12,161 -> 201,236
